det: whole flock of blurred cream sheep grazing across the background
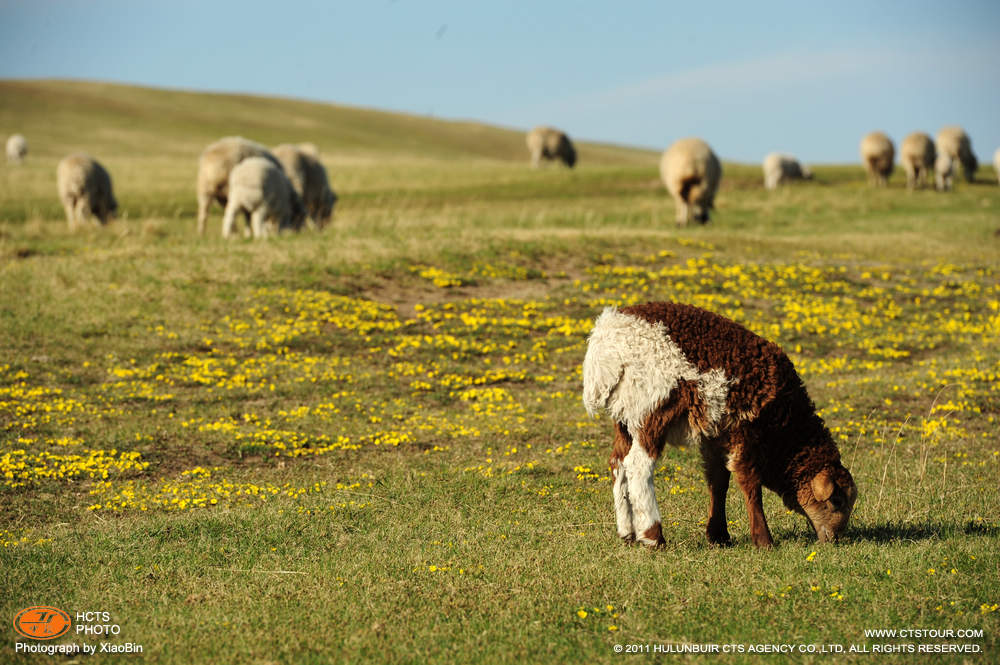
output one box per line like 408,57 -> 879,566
7,126 -> 1000,233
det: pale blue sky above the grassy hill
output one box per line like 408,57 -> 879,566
0,0 -> 1000,162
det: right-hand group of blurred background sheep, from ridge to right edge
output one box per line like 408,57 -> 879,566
527,127 -> 1000,225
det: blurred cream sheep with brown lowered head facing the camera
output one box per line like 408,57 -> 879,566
660,138 -> 722,226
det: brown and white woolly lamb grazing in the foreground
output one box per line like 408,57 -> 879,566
583,302 -> 857,547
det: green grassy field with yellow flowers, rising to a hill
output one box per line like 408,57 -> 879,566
0,82 -> 1000,664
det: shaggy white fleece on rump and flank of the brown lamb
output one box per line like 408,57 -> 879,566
583,307 -> 733,436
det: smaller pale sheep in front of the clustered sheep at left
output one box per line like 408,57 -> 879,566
222,157 -> 306,238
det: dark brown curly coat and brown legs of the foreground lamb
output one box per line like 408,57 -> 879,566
612,302 -> 855,546
